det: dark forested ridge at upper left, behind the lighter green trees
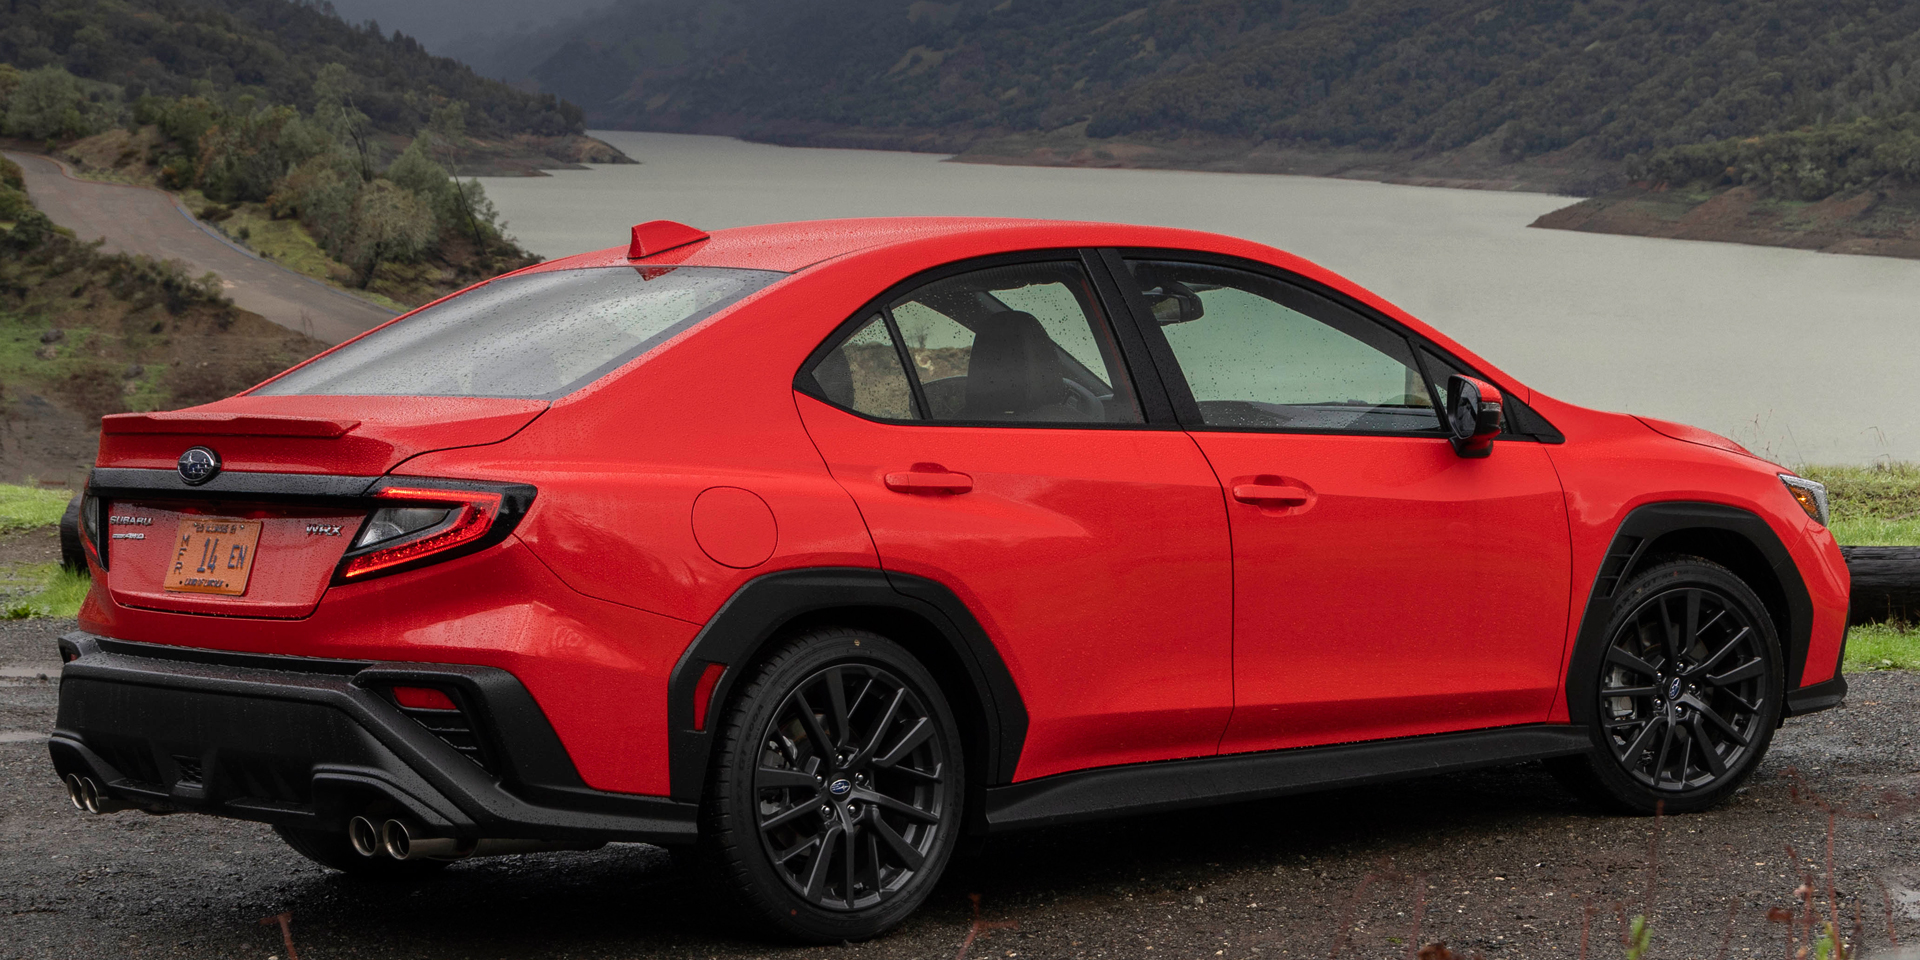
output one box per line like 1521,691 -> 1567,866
0,0 -> 584,136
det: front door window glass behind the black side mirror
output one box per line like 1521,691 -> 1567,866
1127,261 -> 1442,434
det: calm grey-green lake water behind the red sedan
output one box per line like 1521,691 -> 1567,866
486,131 -> 1920,465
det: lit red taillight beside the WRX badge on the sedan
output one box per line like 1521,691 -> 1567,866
334,478 -> 534,582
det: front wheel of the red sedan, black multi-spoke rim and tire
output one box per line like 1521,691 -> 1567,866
1553,557 -> 1786,814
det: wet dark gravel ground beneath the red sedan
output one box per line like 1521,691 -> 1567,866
0,620 -> 1920,960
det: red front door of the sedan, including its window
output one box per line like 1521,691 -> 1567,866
1127,259 -> 1571,753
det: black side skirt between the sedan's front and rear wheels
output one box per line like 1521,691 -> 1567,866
987,724 -> 1594,831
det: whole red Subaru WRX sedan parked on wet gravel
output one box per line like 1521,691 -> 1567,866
52,219 -> 1847,943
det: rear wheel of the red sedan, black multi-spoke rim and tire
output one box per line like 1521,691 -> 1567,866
697,628 -> 966,943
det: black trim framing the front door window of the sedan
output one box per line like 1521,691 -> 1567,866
1098,248 -> 1565,444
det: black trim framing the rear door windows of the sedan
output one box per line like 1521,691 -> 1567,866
793,248 -> 1183,430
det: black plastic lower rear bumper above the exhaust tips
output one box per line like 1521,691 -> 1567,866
48,632 -> 697,843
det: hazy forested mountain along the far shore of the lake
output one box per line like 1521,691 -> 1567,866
491,0 -> 1920,181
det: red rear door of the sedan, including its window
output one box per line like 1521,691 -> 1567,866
797,252 -> 1233,780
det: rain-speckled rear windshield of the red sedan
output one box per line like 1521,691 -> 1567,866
253,267 -> 785,399
